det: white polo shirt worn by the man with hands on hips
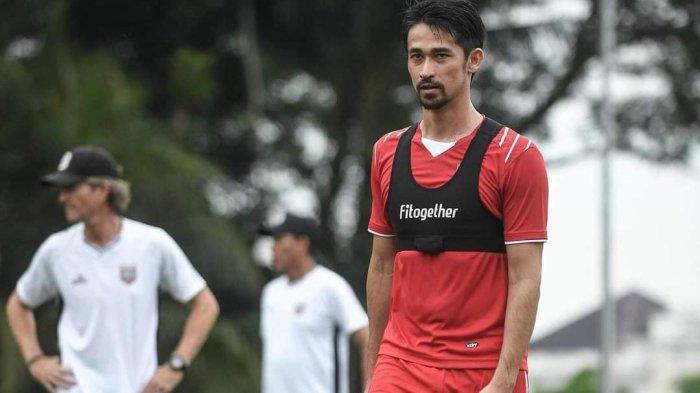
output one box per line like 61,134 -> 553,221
17,218 -> 206,393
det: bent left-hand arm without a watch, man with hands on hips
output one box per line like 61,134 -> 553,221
5,291 -> 76,392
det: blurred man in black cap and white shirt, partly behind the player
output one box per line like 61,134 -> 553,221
260,215 -> 368,393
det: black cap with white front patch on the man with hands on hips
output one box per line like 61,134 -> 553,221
41,146 -> 119,187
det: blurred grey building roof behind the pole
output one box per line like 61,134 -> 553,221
530,292 -> 666,351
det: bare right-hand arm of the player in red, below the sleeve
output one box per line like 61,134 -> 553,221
481,243 -> 543,393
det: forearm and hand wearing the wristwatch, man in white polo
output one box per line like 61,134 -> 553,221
143,288 -> 219,393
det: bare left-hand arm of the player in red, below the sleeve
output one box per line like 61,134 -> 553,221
364,236 -> 396,385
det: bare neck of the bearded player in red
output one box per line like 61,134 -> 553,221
421,99 -> 484,142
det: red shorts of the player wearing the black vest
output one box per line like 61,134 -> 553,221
369,355 -> 529,393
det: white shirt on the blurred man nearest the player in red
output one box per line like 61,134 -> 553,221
260,266 -> 367,393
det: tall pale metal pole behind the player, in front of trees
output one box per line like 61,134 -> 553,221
599,0 -> 617,393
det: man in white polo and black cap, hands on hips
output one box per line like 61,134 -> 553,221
7,146 -> 219,393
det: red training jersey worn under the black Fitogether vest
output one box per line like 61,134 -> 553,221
368,118 -> 548,370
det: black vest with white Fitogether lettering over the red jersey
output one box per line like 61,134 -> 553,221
387,118 -> 506,253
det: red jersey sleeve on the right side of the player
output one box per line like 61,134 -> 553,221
502,138 -> 548,244
